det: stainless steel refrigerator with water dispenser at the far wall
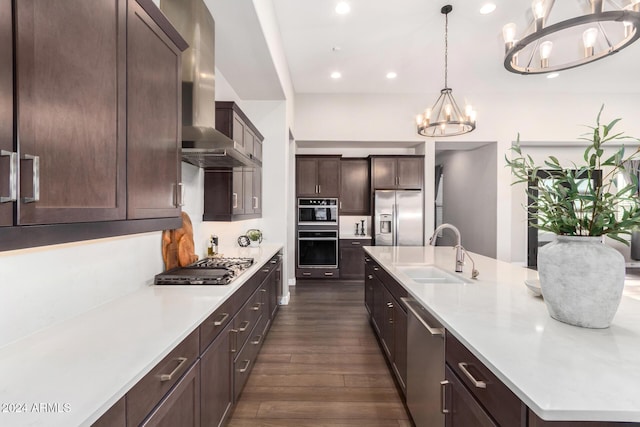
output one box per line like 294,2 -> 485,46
373,190 -> 424,246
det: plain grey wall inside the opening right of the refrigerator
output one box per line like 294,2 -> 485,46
436,144 -> 497,258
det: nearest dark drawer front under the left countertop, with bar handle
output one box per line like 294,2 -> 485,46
126,329 -> 199,426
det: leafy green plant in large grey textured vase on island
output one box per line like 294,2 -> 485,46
506,106 -> 640,328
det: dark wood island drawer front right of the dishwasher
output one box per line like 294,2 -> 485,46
445,331 -> 523,426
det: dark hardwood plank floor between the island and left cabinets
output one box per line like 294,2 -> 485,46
227,281 -> 412,427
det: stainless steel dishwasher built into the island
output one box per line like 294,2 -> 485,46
402,298 -> 444,427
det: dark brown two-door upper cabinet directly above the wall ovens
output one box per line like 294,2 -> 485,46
296,156 -> 340,197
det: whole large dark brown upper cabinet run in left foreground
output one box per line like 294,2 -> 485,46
0,0 -> 187,250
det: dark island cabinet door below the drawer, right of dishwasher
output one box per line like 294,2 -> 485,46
443,365 -> 498,427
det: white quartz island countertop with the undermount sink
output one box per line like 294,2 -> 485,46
365,246 -> 640,422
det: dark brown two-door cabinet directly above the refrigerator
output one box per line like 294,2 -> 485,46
371,156 -> 424,190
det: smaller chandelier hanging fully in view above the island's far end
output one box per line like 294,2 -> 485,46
416,5 -> 476,136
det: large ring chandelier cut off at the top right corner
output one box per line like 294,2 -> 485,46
502,0 -> 640,74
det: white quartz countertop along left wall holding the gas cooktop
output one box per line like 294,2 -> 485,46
0,244 -> 282,427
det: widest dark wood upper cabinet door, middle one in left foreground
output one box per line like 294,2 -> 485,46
14,0 -> 126,225
